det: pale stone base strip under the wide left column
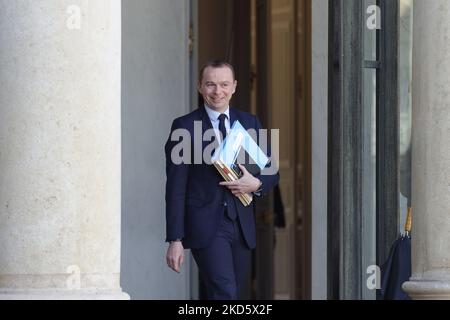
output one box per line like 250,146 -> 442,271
0,289 -> 130,300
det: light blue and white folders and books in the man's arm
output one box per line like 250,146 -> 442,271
211,121 -> 269,206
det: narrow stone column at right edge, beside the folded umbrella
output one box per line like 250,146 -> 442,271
403,0 -> 450,299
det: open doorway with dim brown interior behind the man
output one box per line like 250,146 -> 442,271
193,0 -> 311,299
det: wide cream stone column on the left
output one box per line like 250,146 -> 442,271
0,0 -> 129,299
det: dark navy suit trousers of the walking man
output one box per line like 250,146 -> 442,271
191,212 -> 251,300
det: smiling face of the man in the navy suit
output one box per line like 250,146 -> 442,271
198,67 -> 237,112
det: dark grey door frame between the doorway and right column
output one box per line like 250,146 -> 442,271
327,0 -> 399,299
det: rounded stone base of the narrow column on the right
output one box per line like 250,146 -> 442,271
402,280 -> 450,300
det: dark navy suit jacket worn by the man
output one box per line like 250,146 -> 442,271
165,107 -> 279,249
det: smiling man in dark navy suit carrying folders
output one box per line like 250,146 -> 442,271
165,61 -> 279,299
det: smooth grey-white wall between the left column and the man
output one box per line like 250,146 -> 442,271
121,0 -> 190,299
